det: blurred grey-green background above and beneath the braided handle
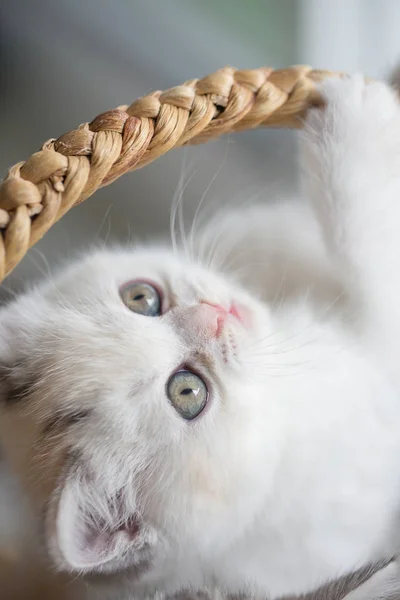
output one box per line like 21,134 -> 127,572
0,0 -> 400,298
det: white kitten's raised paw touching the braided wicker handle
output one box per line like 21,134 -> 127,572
306,75 -> 400,141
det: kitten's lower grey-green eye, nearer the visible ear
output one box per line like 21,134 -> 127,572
167,371 -> 208,421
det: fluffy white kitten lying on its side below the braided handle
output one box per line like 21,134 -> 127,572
0,77 -> 400,600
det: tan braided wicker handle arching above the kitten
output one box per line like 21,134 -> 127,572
0,66 -> 331,281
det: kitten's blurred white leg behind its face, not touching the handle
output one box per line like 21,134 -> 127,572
196,198 -> 341,306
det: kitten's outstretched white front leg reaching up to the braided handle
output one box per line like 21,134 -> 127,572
302,76 -> 400,356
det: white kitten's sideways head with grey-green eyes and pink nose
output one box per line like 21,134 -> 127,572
0,249 -> 279,572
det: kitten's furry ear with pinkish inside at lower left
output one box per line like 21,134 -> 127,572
47,468 -> 157,573
